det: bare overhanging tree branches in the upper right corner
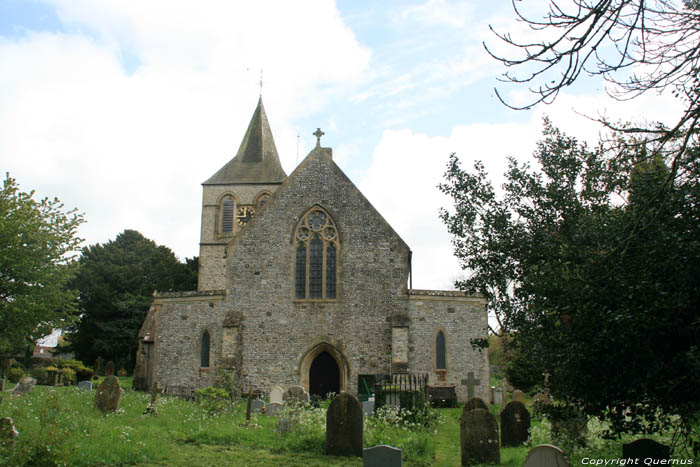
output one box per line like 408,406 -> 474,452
484,0 -> 700,168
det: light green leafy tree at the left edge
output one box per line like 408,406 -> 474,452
0,174 -> 83,352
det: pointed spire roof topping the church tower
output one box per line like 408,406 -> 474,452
203,97 -> 287,185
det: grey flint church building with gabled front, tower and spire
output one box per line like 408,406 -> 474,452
134,99 -> 489,401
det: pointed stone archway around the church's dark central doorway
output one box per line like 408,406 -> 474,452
299,341 -> 350,397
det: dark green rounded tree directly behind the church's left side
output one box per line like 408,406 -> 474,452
70,230 -> 197,370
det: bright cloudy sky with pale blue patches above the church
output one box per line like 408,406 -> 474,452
0,0 -> 678,290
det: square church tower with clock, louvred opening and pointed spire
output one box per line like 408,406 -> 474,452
197,97 -> 287,291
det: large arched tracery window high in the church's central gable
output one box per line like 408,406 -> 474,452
294,207 -> 338,300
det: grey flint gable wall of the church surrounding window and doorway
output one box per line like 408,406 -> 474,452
226,149 -> 408,393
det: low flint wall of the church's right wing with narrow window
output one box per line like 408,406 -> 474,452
408,290 -> 490,402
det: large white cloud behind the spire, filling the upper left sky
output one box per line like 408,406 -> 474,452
0,0 -> 370,256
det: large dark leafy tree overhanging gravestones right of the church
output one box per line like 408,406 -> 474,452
441,121 -> 700,444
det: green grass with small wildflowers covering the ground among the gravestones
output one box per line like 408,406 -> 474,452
0,378 -> 697,467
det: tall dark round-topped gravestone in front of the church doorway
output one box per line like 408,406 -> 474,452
326,392 -> 363,457
